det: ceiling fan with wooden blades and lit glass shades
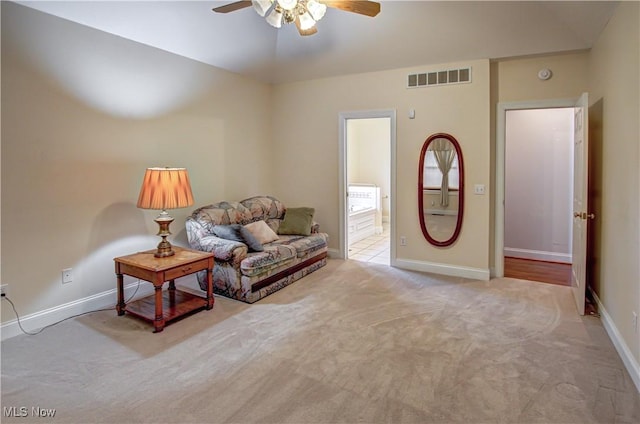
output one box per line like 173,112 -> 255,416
212,0 -> 380,35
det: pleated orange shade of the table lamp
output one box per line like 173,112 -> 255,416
138,168 -> 193,210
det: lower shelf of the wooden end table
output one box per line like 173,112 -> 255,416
124,289 -> 207,322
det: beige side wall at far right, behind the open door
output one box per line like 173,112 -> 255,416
588,2 -> 640,364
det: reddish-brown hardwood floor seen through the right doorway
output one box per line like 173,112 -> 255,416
504,256 -> 571,286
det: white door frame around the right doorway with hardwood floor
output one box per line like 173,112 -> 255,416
492,97 -> 578,278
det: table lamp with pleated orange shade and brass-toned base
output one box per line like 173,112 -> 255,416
138,168 -> 193,258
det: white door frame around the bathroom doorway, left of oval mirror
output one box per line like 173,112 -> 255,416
338,109 -> 396,266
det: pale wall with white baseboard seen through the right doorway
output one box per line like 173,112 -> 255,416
504,108 -> 573,263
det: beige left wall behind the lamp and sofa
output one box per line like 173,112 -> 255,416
1,2 -> 272,321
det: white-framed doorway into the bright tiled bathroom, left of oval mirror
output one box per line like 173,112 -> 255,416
340,110 -> 396,265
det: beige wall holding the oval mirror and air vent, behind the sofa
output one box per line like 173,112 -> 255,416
273,60 -> 490,270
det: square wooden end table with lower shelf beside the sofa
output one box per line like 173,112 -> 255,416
114,246 -> 215,333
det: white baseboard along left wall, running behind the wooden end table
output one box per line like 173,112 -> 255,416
0,281 -> 154,340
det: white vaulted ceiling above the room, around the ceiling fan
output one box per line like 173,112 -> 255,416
19,0 -> 618,83
